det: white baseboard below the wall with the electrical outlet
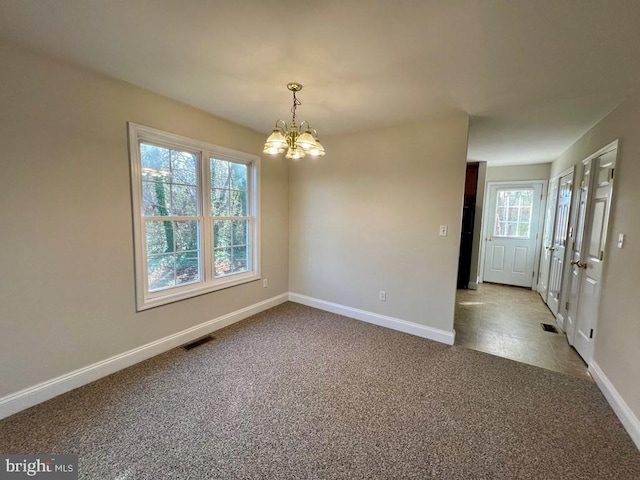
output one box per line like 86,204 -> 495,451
289,293 -> 455,345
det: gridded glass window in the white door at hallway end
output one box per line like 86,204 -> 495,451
493,188 -> 533,238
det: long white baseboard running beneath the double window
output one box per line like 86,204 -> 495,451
0,293 -> 289,419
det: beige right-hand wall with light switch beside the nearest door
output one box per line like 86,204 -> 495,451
551,95 -> 640,418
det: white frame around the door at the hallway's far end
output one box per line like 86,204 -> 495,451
478,180 -> 549,291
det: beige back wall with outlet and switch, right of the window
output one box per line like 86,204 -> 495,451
289,115 -> 468,332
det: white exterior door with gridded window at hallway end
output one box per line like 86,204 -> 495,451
483,182 -> 543,288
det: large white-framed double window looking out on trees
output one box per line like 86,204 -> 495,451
129,123 -> 260,310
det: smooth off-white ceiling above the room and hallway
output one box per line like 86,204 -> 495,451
0,0 -> 640,165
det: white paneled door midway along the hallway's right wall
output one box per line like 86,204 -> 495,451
547,172 -> 573,315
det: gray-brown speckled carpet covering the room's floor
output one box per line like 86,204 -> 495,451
0,303 -> 640,480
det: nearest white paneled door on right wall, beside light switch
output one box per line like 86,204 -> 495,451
573,149 -> 617,363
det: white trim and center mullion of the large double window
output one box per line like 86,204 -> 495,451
128,122 -> 261,311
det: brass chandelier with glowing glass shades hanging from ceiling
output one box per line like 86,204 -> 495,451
262,82 -> 324,160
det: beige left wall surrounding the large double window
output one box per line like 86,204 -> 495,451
0,44 -> 288,397
